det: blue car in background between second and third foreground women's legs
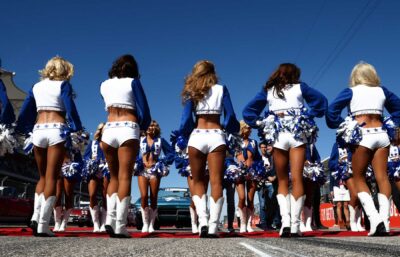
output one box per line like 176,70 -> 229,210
133,187 -> 191,230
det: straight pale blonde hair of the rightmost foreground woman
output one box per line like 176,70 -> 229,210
350,62 -> 381,87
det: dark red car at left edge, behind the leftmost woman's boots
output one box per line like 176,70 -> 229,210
0,186 -> 33,224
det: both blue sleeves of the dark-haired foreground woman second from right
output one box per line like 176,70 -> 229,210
242,82 -> 328,128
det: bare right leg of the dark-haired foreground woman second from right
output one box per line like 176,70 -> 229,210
289,145 -> 306,200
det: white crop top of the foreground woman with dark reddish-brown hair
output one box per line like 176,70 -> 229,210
267,84 -> 304,113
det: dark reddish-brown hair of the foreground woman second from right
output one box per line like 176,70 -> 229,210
264,63 -> 301,99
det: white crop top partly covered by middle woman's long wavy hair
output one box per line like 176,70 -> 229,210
196,84 -> 224,114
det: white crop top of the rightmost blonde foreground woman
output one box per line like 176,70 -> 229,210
350,85 -> 386,115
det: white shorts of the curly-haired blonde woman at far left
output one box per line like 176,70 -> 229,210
32,123 -> 67,148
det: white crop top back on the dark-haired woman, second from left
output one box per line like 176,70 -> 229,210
100,78 -> 135,110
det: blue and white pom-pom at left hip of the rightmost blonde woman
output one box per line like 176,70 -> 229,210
336,116 -> 364,147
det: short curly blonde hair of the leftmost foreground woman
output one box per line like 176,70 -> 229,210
39,56 -> 74,81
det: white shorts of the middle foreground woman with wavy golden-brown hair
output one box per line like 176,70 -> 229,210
188,129 -> 226,154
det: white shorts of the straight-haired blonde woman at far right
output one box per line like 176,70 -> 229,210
358,127 -> 390,150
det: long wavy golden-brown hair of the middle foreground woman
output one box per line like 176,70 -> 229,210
181,60 -> 218,104
